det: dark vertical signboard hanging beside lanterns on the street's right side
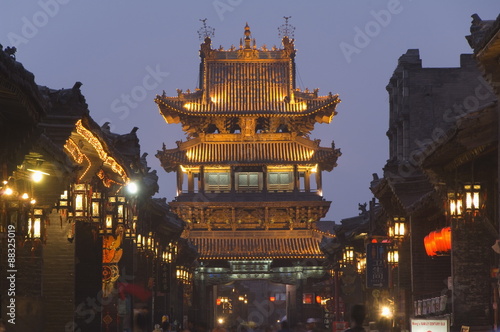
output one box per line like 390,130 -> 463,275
366,243 -> 389,288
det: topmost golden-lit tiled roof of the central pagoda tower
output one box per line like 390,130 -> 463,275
155,25 -> 340,119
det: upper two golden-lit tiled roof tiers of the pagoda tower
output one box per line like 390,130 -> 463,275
155,24 -> 341,172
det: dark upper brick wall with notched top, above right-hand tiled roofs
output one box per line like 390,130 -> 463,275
387,50 -> 495,166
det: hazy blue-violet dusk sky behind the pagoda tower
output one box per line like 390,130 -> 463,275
0,0 -> 500,222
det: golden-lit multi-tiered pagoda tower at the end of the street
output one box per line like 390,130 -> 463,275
155,18 -> 341,323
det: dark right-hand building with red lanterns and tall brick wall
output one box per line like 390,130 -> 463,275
371,13 -> 498,330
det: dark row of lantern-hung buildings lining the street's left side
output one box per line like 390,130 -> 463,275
0,48 -> 186,331
